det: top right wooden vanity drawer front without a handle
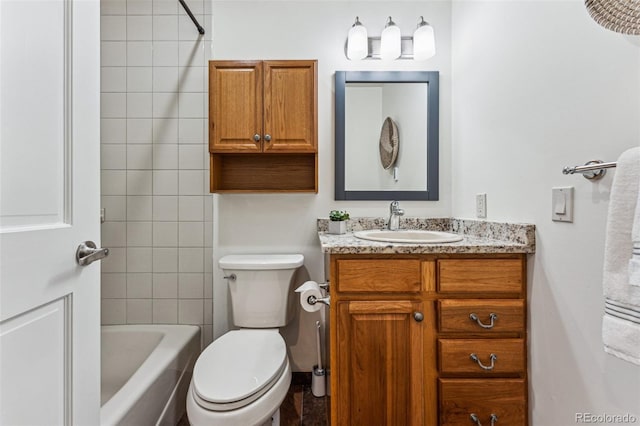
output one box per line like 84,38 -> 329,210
438,259 -> 524,295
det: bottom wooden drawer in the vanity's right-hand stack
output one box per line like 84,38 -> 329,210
438,379 -> 527,426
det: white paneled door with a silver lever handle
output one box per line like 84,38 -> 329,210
0,0 -> 100,426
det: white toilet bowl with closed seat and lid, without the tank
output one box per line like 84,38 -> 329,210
187,329 -> 291,426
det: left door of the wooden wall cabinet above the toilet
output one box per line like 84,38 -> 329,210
209,61 -> 263,153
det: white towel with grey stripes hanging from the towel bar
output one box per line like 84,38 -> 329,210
602,147 -> 640,365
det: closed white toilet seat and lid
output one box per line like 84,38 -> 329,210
192,329 -> 287,411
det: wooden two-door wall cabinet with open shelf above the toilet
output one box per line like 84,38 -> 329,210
209,60 -> 318,192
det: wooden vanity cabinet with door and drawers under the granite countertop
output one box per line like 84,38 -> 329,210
330,254 -> 528,426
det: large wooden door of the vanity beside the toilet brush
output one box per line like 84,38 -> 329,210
332,300 -> 424,426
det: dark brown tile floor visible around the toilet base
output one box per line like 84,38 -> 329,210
177,373 -> 330,426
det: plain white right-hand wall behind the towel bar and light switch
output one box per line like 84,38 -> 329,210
452,0 -> 640,426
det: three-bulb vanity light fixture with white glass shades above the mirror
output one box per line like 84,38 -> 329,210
344,16 -> 436,61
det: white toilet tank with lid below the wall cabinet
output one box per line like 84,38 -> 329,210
218,254 -> 304,328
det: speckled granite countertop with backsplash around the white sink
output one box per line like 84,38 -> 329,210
318,217 -> 535,254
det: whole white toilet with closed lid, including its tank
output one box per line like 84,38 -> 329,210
187,254 -> 304,426
